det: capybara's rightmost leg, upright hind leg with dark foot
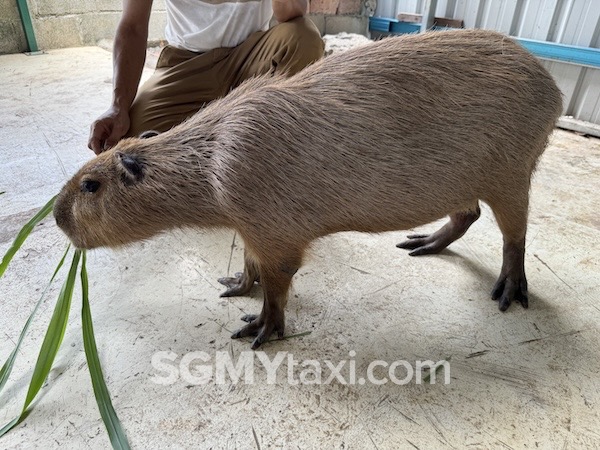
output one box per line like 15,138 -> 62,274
490,199 -> 529,311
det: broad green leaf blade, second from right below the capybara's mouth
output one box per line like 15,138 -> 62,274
0,249 -> 81,437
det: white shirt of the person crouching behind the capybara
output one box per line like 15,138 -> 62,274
165,0 -> 273,52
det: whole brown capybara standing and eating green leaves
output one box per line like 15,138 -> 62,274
54,30 -> 562,348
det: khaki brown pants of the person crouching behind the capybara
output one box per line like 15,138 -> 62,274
127,17 -> 324,136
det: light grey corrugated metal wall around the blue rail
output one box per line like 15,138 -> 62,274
375,0 -> 600,124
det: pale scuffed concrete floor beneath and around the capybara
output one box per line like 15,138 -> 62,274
0,48 -> 600,449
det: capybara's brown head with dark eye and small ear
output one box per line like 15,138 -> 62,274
54,135 -> 220,249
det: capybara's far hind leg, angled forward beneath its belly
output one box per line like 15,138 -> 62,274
396,203 -> 481,256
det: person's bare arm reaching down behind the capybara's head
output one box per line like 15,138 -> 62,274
88,0 -> 152,154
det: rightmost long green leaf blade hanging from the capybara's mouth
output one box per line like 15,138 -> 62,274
81,251 -> 130,449
